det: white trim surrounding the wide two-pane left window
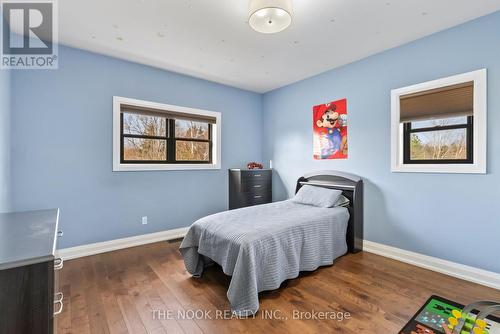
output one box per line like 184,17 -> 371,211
113,96 -> 222,172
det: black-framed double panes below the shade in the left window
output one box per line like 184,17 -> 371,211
120,111 -> 213,164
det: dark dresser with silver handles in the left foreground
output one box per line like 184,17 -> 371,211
0,209 -> 63,334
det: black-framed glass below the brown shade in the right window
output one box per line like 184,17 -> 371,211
403,116 -> 473,164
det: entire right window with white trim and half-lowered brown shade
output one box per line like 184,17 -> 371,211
391,70 -> 486,173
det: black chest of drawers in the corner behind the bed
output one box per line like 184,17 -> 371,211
229,169 -> 273,210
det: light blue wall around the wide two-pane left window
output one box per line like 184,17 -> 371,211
12,47 -> 262,248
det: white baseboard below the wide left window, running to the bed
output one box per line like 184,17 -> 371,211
56,227 -> 189,260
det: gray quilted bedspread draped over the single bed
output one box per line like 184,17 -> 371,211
180,200 -> 349,316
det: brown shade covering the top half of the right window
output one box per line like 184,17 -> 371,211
400,81 -> 474,122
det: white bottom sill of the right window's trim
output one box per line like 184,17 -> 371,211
391,164 -> 486,174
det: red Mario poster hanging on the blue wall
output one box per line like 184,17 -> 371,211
313,99 -> 348,160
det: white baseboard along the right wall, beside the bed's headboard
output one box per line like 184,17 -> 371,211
363,240 -> 500,290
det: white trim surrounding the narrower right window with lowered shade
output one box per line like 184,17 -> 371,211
391,69 -> 487,174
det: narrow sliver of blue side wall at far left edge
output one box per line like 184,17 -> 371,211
0,70 -> 12,212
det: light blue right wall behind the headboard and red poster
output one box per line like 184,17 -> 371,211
263,12 -> 500,272
